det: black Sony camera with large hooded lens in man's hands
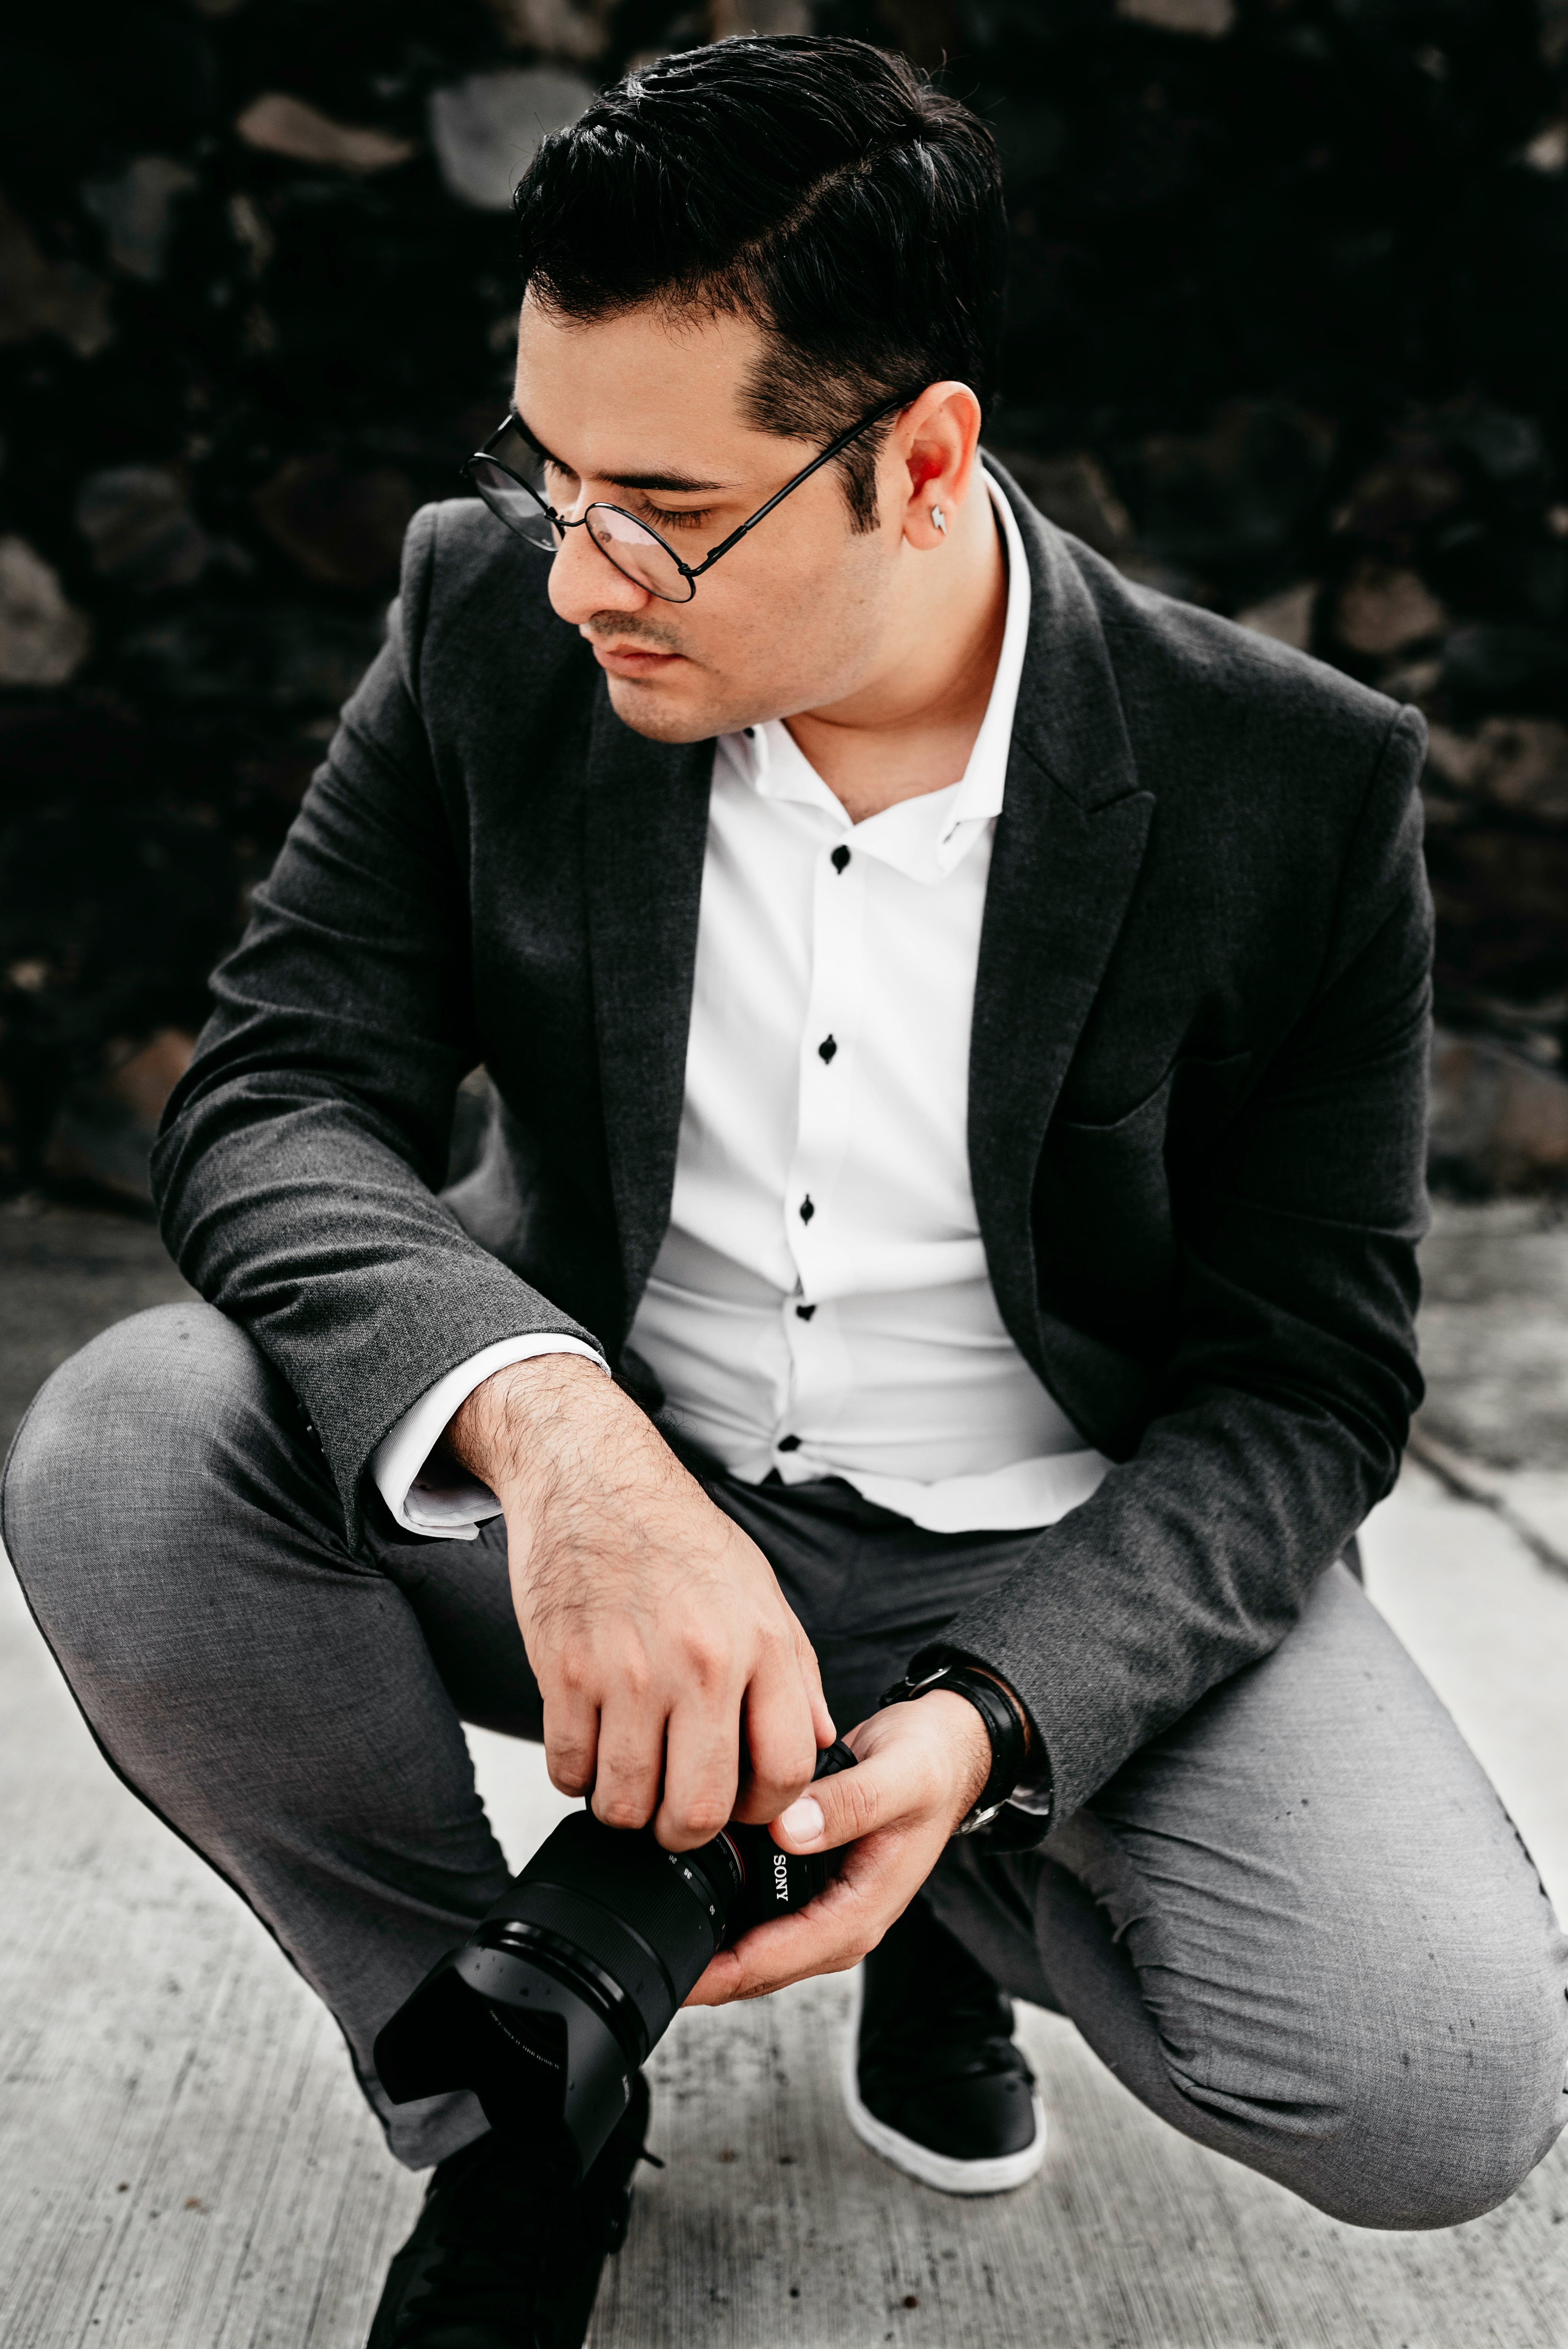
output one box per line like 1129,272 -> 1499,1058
375,1740 -> 854,2185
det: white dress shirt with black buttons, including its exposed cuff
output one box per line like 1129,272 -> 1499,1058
373,486 -> 1108,1538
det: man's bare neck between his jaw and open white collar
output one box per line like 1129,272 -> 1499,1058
786,467 -> 1007,825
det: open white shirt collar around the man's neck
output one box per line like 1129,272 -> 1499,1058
721,470 -> 1030,881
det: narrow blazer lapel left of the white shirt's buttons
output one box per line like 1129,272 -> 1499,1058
587,684 -> 714,1334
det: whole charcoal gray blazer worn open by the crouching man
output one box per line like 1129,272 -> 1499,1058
155,458 -> 1429,1811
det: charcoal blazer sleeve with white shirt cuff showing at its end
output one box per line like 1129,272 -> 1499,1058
153,508 -> 596,1538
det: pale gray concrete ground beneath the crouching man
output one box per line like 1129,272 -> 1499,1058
0,1207 -> 1568,2349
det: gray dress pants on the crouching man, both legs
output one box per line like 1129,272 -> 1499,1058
0,1304 -> 1568,2227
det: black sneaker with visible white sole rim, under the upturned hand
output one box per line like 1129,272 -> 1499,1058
843,1900 -> 1044,2194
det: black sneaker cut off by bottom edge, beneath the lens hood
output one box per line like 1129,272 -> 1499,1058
366,2074 -> 652,2349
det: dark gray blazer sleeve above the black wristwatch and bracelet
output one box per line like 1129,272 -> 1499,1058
927,712 -> 1432,1841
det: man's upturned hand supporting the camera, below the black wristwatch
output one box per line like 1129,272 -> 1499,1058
685,1689 -> 991,2006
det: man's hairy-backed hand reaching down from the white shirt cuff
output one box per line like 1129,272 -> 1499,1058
446,1353 -> 833,1851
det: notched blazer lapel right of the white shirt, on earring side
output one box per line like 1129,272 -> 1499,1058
969,460 -> 1155,1369
